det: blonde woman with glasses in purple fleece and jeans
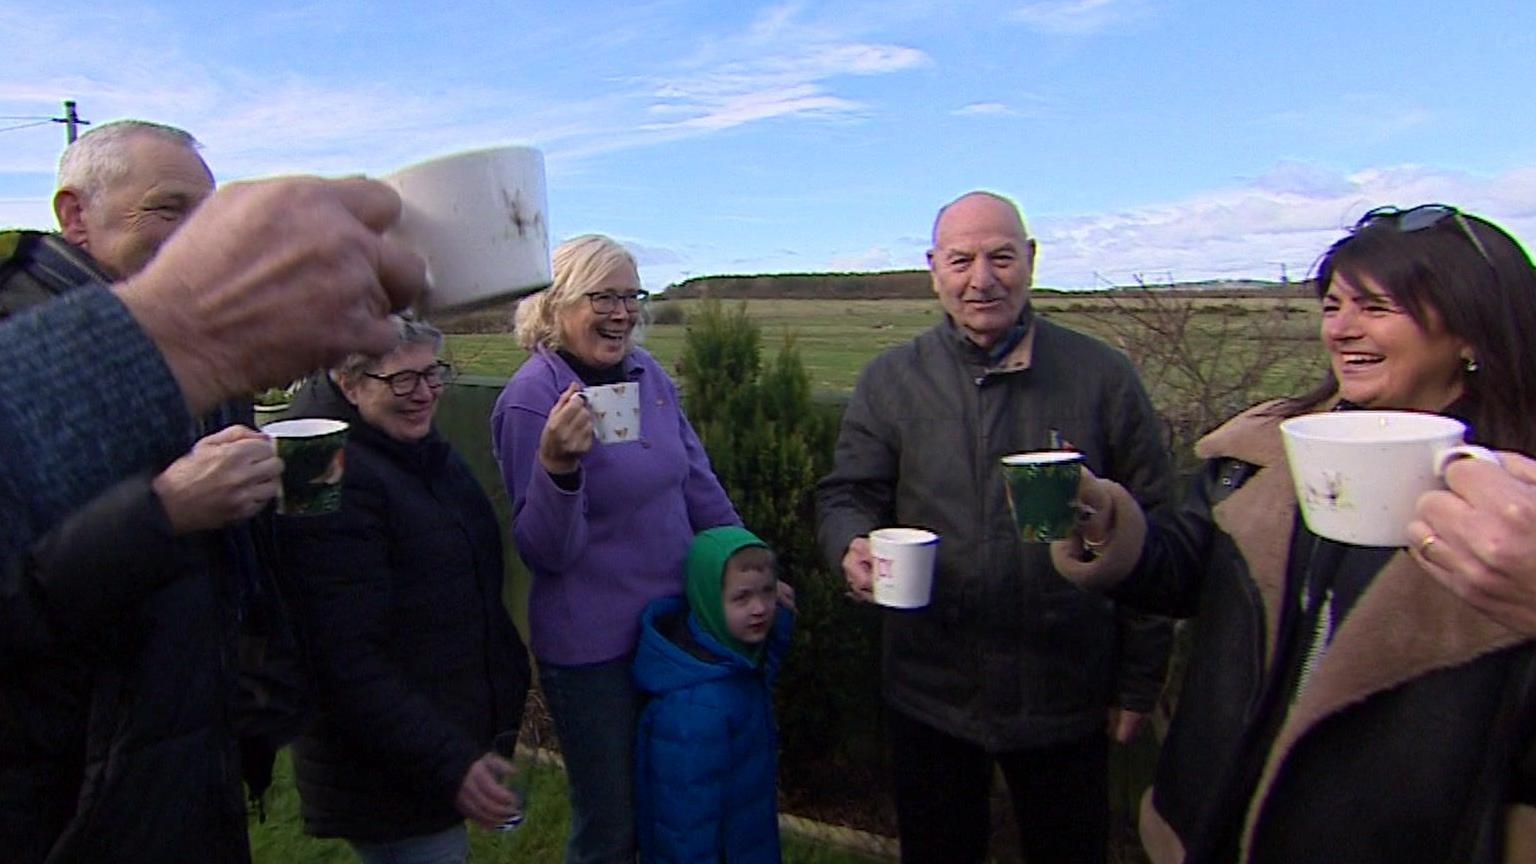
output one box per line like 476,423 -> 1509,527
492,235 -> 740,864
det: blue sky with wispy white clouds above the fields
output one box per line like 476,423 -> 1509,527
0,0 -> 1536,291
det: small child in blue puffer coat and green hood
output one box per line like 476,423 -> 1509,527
634,526 -> 794,864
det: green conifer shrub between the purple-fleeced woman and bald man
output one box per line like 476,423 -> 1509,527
679,300 -> 879,764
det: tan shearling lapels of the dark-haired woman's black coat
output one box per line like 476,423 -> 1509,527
1195,403 -> 1525,859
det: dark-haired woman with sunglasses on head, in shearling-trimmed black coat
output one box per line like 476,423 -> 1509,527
1052,204 -> 1536,864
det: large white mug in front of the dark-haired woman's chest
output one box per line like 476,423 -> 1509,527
1279,410 -> 1499,546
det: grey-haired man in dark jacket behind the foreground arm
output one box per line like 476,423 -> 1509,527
0,120 -> 301,862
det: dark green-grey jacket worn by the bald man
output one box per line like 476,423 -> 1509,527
817,310 -> 1172,750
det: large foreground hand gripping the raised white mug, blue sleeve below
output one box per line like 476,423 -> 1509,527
115,177 -> 425,414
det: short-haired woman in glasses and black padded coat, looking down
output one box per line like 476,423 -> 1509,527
278,318 -> 530,864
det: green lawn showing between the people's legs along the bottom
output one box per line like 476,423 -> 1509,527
250,750 -> 876,864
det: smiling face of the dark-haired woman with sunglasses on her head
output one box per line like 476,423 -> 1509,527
1322,272 -> 1468,412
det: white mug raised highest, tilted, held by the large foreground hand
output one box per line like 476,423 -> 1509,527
382,148 -> 551,312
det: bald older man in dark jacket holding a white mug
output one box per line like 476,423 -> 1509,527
817,192 -> 1170,864
